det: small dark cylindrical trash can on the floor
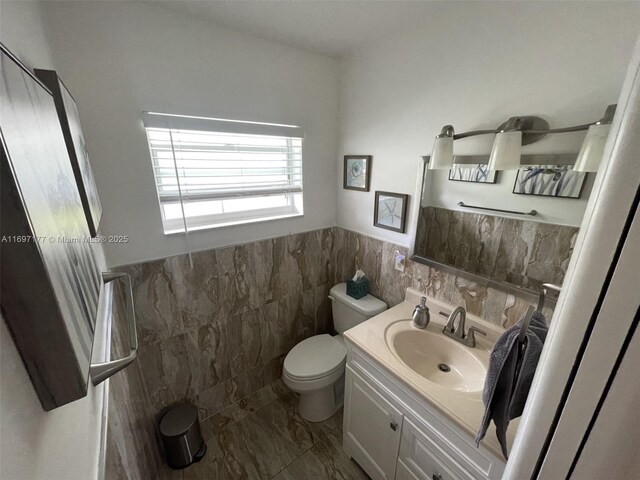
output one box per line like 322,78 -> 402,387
160,403 -> 207,470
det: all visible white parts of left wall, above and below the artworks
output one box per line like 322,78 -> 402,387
0,1 -> 106,480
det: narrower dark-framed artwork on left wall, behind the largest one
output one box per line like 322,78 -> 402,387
35,69 -> 102,237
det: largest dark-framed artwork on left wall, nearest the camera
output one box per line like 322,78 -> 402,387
0,44 -> 101,410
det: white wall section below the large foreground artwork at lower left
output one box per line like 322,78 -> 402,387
0,317 -> 106,480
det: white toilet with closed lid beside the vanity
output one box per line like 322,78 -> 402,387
282,283 -> 387,422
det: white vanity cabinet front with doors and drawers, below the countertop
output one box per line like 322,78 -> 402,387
343,343 -> 504,480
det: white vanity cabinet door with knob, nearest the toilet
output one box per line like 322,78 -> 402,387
344,367 -> 403,480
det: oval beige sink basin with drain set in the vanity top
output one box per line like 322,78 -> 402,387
385,320 -> 487,392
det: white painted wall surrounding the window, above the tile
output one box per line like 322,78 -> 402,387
40,1 -> 338,265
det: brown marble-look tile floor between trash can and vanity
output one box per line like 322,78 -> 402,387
179,382 -> 369,480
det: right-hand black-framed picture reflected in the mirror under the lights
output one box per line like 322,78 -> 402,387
513,165 -> 587,198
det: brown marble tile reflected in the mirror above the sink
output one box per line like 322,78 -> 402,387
416,206 -> 579,290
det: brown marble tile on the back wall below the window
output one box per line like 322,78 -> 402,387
119,229 -> 333,418
